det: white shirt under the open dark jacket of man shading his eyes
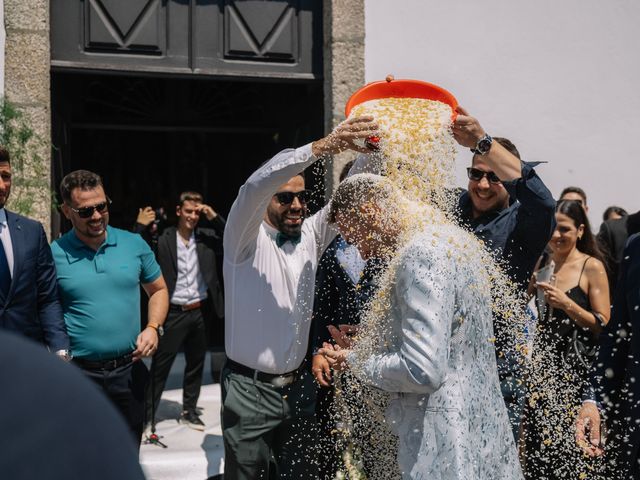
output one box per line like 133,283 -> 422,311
171,231 -> 207,305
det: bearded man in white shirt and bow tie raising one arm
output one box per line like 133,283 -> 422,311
222,117 -> 378,480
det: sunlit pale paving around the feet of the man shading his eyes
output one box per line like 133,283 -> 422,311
140,356 -> 224,480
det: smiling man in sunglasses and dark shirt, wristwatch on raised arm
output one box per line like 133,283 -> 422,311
453,107 -> 556,439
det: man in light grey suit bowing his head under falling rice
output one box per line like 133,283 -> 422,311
320,174 -> 522,479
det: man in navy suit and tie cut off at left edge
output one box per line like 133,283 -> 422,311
0,146 -> 70,359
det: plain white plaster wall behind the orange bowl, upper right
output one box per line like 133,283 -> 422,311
365,0 -> 640,230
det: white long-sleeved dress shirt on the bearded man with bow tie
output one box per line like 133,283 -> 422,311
224,144 -> 337,374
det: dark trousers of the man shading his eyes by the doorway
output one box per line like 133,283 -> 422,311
145,307 -> 207,425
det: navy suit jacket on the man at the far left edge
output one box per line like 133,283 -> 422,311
0,211 -> 68,352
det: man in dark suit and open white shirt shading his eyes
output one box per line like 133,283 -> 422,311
146,192 -> 225,430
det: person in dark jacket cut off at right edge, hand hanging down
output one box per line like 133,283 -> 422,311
576,234 -> 640,479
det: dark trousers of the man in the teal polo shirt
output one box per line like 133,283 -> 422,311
78,361 -> 149,445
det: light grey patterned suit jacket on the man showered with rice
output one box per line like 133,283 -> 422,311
349,226 -> 522,480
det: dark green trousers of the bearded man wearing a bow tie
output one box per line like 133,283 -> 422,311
221,366 -> 318,480
